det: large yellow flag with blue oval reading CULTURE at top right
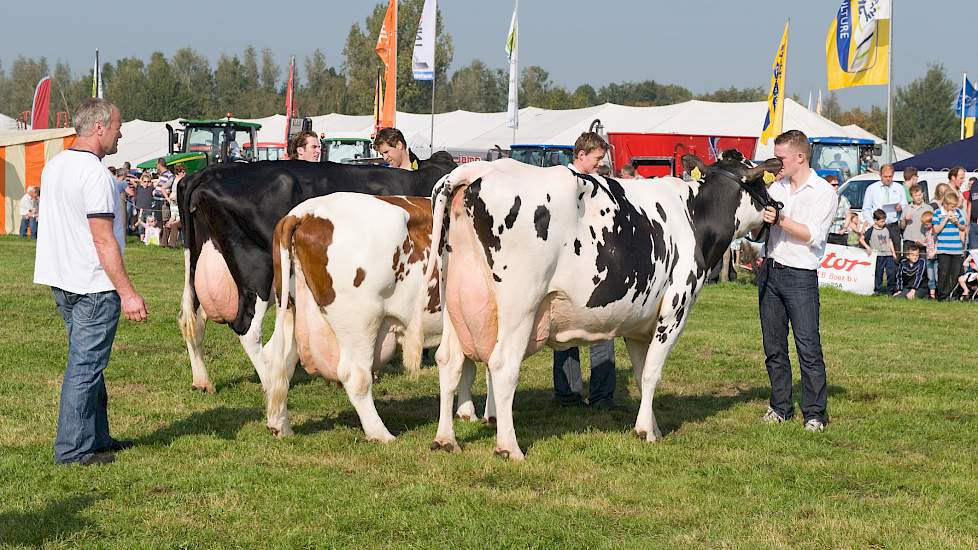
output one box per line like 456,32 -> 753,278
825,0 -> 891,90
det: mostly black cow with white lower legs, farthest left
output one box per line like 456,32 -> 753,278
177,152 -> 456,393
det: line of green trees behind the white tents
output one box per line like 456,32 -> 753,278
0,0 -> 959,152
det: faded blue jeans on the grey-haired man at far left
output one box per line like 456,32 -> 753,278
51,288 -> 121,464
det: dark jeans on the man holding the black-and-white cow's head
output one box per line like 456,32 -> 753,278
757,259 -> 828,423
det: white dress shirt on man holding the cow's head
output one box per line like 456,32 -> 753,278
767,169 -> 839,269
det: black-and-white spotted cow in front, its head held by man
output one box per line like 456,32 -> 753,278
432,152 -> 781,459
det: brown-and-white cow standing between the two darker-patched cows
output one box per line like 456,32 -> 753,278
266,193 -> 475,442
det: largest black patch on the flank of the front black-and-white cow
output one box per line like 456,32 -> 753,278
582,176 -> 666,307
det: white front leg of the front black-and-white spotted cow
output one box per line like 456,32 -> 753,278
634,288 -> 694,442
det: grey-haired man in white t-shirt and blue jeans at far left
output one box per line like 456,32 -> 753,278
34,99 -> 146,465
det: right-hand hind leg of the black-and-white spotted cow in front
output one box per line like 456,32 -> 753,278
488,324 -> 533,460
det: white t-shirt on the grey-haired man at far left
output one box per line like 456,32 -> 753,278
34,149 -> 122,294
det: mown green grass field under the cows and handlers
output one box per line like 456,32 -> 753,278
0,237 -> 978,548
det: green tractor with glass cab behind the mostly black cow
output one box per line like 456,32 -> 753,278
137,115 -> 261,174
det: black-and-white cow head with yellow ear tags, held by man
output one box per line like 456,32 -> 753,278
682,149 -> 781,269
